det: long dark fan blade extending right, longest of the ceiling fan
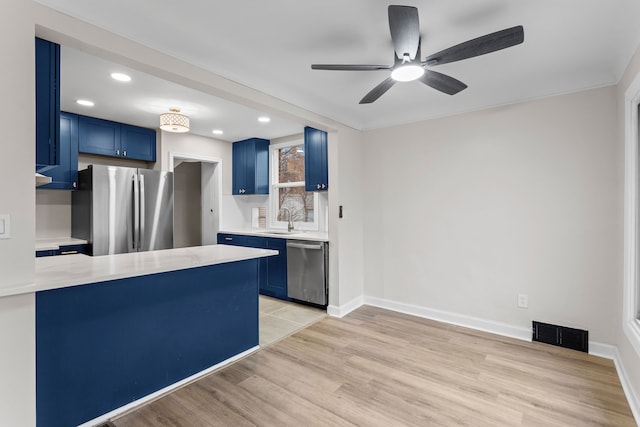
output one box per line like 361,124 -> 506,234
423,25 -> 524,65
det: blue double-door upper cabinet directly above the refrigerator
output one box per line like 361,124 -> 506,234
78,116 -> 156,162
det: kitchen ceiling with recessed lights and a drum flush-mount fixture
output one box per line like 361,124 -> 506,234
60,46 -> 303,141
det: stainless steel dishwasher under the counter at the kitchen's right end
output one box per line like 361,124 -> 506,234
287,240 -> 329,306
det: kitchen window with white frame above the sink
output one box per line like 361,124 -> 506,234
269,141 -> 318,230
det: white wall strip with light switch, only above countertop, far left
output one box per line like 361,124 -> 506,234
0,0 -> 35,288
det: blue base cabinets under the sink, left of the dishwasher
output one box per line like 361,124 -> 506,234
218,233 -> 290,301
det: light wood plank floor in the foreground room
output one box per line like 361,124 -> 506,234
114,307 -> 636,427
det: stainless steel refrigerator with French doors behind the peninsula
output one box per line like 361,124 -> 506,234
71,165 -> 173,256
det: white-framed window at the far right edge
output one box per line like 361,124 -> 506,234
623,74 -> 640,355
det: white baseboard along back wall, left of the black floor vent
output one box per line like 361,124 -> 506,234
364,296 -> 531,341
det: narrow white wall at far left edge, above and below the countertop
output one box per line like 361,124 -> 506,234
0,0 -> 35,426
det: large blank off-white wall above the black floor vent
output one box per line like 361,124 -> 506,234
364,87 -> 621,344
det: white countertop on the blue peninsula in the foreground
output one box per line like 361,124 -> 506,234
0,245 -> 278,296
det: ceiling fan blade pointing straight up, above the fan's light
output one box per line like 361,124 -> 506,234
389,5 -> 420,60
